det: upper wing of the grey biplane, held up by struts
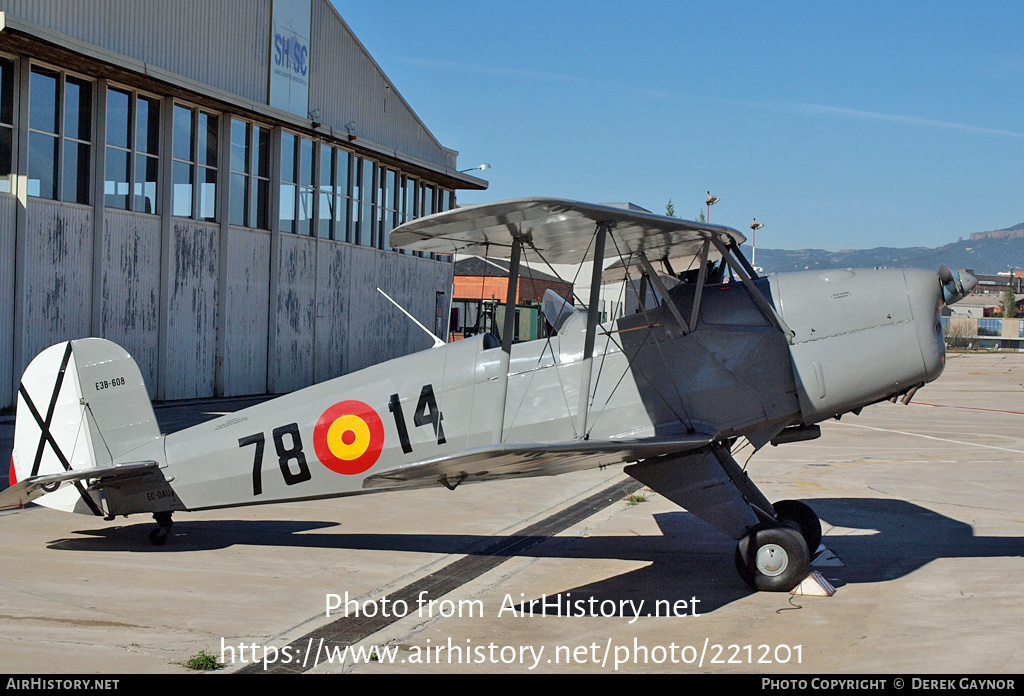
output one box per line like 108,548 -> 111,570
390,198 -> 746,263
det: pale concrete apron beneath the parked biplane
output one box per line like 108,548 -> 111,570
0,353 -> 1024,676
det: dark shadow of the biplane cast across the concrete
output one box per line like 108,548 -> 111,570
48,498 -> 1024,616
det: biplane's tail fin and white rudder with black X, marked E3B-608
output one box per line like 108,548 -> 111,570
10,339 -> 162,515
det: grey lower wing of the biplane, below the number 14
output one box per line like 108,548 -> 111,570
362,434 -> 714,488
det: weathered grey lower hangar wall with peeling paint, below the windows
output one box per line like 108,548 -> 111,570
0,197 -> 453,407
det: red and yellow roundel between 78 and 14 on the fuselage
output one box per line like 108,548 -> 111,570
313,401 -> 384,475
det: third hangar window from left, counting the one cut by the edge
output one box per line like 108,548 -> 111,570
103,87 -> 160,214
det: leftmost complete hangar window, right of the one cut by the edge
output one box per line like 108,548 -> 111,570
28,67 -> 92,204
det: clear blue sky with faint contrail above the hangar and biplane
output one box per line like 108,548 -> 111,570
334,0 -> 1024,250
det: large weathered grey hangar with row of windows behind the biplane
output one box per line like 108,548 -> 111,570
0,0 -> 486,408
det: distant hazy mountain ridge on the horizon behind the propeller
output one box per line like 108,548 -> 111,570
743,222 -> 1024,273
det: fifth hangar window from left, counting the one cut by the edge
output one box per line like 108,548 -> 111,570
228,119 -> 270,229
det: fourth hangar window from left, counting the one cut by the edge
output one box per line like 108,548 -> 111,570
171,104 -> 217,220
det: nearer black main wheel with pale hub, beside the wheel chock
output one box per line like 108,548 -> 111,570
736,527 -> 811,592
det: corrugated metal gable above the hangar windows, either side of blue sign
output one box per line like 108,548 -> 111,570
0,0 -> 456,168
